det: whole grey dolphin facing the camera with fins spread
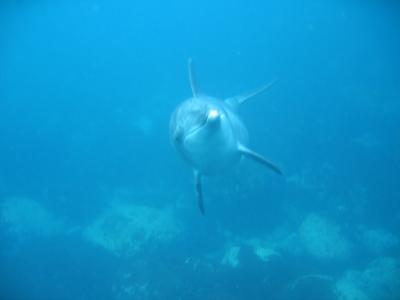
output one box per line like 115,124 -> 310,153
169,59 -> 282,215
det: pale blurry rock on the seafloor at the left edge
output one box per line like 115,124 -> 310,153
0,197 -> 64,237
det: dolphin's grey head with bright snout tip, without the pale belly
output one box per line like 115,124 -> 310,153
170,98 -> 224,148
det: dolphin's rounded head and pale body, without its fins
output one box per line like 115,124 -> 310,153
170,96 -> 241,174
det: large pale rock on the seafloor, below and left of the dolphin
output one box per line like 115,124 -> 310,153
84,204 -> 182,257
